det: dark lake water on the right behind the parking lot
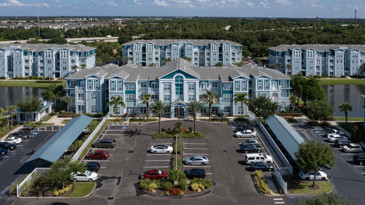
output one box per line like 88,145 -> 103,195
322,85 -> 365,117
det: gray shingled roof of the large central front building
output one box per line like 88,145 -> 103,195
66,59 -> 290,82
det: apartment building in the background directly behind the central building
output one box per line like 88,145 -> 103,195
122,39 -> 242,67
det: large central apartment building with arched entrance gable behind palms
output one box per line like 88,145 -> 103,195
66,59 -> 290,117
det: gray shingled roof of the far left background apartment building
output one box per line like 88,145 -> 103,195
0,44 -> 95,52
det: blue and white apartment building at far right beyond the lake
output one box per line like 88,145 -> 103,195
269,44 -> 365,77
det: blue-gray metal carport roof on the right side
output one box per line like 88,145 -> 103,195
265,115 -> 304,160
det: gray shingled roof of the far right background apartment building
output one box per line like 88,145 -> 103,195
269,44 -> 365,52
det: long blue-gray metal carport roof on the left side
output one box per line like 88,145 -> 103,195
26,115 -> 93,163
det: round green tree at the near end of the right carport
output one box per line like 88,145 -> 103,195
295,140 -> 335,187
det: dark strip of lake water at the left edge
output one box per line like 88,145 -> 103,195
0,87 -> 43,108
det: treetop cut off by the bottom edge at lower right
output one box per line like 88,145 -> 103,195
299,192 -> 351,205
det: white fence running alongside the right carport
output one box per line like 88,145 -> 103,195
249,112 -> 293,174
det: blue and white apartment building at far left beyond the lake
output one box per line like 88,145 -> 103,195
0,44 -> 95,78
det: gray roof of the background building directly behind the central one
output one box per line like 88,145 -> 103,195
123,39 -> 242,46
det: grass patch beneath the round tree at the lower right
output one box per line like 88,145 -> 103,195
292,181 -> 332,194
